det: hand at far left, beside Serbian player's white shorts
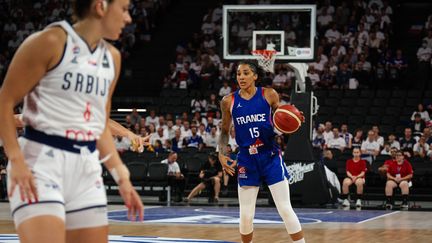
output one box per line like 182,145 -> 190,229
8,155 -> 39,203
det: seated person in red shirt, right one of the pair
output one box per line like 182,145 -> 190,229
385,150 -> 413,209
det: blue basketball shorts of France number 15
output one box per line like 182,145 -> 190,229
237,149 -> 289,187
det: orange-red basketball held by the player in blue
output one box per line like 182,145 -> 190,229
273,105 -> 304,134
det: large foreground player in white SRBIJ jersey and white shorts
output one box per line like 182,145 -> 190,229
0,0 -> 143,243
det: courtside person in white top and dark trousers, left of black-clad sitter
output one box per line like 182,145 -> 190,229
161,152 -> 185,202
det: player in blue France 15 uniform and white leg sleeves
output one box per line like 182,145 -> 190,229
219,61 -> 305,243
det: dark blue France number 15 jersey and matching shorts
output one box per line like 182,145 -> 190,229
231,87 -> 288,186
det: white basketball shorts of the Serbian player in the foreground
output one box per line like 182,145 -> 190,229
8,137 -> 108,229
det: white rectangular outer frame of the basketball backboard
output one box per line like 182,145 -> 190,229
222,4 -> 316,62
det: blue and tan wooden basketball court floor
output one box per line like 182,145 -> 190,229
0,203 -> 432,243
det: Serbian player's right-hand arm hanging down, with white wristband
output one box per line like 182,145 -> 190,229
97,45 -> 144,221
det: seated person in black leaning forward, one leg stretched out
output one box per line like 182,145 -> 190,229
185,154 -> 222,203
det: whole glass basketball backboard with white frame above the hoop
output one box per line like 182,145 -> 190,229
222,5 -> 316,62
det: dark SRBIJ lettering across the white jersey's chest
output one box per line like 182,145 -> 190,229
62,72 -> 110,96
